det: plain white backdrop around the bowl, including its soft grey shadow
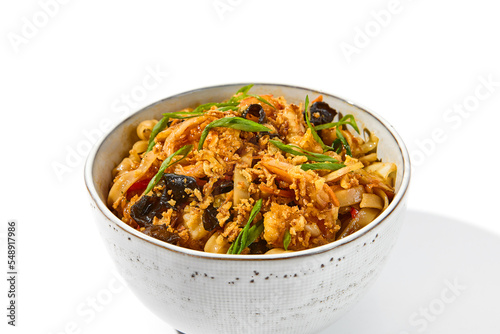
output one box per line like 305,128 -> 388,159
0,0 -> 500,334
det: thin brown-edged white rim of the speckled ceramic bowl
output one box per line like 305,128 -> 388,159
84,82 -> 411,261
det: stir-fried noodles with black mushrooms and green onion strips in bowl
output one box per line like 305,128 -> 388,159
108,85 -> 396,254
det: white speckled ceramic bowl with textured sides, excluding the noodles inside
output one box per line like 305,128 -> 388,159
85,84 -> 410,334
